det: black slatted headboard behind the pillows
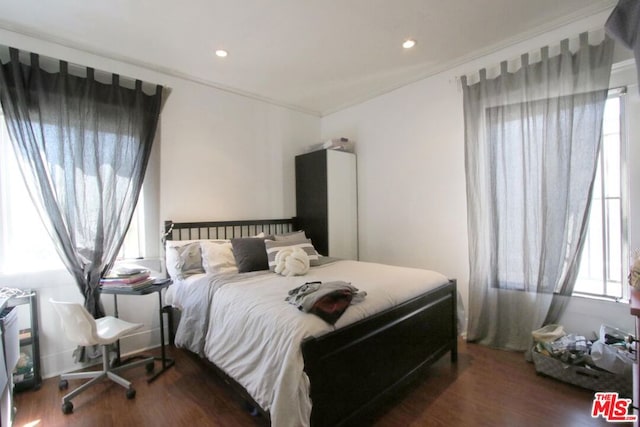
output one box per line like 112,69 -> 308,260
163,218 -> 295,241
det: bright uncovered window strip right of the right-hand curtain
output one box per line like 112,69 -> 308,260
573,90 -> 629,300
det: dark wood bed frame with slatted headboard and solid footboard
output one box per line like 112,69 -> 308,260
164,218 -> 458,426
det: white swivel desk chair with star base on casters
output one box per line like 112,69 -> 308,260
49,299 -> 154,414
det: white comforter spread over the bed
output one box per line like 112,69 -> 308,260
173,261 -> 447,427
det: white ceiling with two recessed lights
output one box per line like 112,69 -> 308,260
0,0 -> 615,115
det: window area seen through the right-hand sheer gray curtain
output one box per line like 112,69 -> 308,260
488,94 -> 601,293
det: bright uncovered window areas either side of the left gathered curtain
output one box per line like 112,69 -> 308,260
0,110 -> 145,274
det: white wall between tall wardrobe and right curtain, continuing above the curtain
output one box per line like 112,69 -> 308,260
322,9 -> 640,335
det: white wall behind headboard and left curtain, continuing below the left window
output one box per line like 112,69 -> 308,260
0,30 -> 320,377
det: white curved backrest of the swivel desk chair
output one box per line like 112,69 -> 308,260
49,299 -> 98,346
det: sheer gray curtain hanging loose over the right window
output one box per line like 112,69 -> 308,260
462,33 -> 613,351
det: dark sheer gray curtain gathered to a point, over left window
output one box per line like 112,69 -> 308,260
0,48 -> 162,338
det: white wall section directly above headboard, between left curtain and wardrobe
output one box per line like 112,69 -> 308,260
160,82 -> 320,221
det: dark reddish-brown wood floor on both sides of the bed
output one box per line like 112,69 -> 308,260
14,342 -> 620,427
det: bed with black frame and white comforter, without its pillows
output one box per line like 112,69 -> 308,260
165,219 -> 458,427
